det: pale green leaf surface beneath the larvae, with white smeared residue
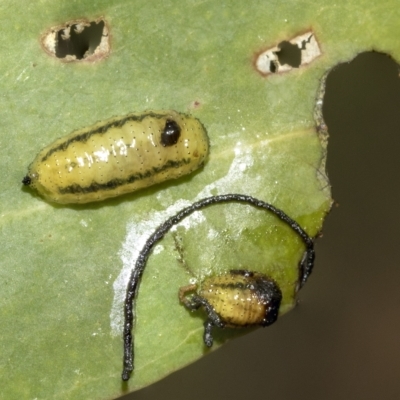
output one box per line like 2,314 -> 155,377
0,0 -> 400,399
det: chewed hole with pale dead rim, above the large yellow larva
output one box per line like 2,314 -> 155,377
41,19 -> 110,62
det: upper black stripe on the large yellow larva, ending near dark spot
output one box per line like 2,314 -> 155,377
41,112 -> 178,162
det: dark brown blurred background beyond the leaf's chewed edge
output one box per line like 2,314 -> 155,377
121,53 -> 400,400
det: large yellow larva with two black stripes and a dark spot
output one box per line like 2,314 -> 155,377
22,111 -> 209,204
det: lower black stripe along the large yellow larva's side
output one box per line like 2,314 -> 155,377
58,158 -> 190,194
